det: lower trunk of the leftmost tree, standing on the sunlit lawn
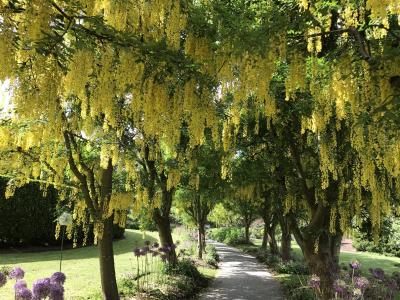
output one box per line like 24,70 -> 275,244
98,217 -> 119,300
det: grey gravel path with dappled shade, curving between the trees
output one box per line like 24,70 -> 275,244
200,242 -> 284,300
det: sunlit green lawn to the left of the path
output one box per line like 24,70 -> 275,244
0,229 -> 158,300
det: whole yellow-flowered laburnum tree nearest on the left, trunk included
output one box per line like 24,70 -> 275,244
0,0 -> 217,299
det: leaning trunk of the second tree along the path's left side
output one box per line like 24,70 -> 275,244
153,209 -> 177,264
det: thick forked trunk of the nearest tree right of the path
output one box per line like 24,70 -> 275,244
302,234 -> 342,300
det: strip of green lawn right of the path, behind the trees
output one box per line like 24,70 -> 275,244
253,240 -> 400,274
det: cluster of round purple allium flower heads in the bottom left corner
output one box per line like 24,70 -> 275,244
0,267 -> 66,300
